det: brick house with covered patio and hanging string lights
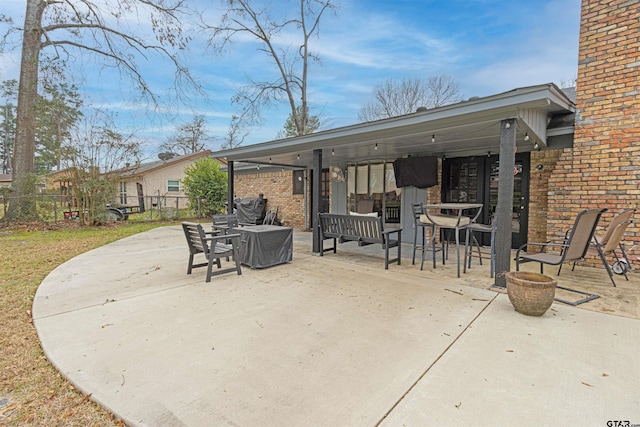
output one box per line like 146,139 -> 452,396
215,0 -> 640,288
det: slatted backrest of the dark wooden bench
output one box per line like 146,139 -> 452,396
318,213 -> 384,243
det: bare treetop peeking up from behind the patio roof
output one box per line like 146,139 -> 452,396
358,76 -> 462,121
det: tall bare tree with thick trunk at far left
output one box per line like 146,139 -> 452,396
0,0 -> 193,219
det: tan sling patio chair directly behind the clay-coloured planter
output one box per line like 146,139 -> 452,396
516,209 -> 607,275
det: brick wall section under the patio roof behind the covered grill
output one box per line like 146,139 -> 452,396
233,171 -> 309,228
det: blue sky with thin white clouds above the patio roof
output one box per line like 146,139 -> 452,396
0,0 -> 580,156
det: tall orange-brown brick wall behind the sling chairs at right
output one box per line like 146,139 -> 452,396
544,0 -> 640,256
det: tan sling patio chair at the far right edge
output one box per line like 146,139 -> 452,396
572,209 -> 636,286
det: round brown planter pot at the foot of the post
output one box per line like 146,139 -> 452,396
506,271 -> 556,316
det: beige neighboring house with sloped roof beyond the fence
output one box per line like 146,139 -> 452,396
114,150 -> 211,209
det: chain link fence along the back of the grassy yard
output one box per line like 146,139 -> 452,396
0,193 -> 210,223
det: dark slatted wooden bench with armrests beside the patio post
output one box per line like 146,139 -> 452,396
318,213 -> 402,270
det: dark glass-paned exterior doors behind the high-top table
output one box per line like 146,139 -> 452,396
442,153 -> 530,249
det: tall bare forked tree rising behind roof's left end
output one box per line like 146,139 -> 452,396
204,0 -> 336,135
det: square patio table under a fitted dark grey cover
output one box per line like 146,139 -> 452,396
231,225 -> 293,268
